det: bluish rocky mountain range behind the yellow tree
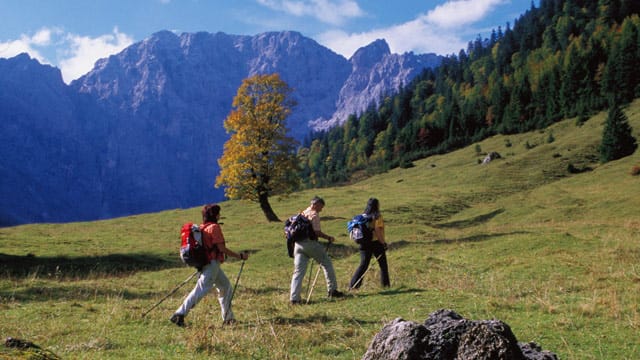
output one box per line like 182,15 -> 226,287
0,31 -> 440,225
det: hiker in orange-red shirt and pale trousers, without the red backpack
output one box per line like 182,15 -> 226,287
170,204 -> 249,326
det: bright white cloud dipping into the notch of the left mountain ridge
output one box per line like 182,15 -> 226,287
60,28 -> 133,83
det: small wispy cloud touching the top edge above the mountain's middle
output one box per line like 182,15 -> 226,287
257,0 -> 365,25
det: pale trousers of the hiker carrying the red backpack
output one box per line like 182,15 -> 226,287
175,260 -> 235,320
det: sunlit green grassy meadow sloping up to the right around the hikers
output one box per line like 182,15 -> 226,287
0,102 -> 640,359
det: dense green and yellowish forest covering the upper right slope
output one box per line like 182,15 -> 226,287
297,0 -> 640,187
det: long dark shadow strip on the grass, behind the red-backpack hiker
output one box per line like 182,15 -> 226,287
0,253 -> 178,280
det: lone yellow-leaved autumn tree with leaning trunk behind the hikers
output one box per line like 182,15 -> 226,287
216,74 -> 300,221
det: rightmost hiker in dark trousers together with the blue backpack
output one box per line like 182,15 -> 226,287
347,198 -> 391,291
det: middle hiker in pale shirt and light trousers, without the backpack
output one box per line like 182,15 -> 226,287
289,196 -> 344,305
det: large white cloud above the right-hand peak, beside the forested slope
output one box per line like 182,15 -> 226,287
317,0 -> 508,58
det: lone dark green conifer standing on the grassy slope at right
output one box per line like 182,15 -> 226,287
600,103 -> 638,163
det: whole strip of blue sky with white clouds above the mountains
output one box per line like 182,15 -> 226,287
0,0 -> 538,83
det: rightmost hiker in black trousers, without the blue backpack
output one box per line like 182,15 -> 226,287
349,198 -> 391,291
